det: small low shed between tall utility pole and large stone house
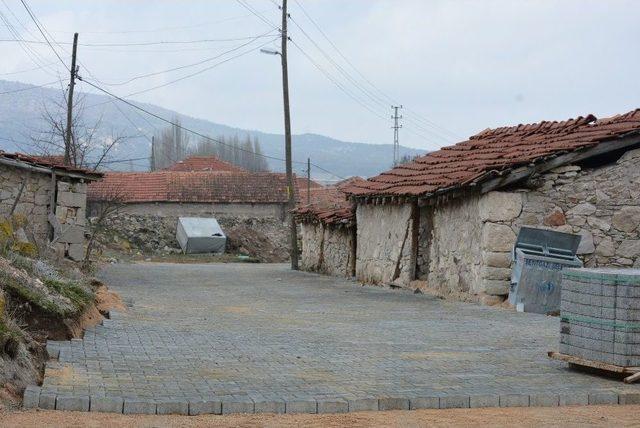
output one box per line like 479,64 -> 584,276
295,186 -> 356,277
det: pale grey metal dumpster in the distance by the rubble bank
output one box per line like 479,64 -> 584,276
176,217 -> 227,254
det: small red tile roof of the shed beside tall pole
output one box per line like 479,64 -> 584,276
295,177 -> 364,227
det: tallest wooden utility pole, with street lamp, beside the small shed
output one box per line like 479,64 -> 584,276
280,0 -> 298,270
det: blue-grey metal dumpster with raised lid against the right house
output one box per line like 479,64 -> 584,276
509,227 -> 582,314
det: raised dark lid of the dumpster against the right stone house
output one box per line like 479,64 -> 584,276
514,226 -> 582,257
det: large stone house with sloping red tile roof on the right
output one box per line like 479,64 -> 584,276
344,110 -> 640,304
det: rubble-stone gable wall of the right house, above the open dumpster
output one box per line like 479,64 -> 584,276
512,149 -> 640,268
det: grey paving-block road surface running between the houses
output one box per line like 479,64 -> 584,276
25,264 -> 640,414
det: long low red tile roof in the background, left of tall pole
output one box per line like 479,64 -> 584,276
87,171 -> 288,203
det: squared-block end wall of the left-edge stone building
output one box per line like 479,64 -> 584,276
54,181 -> 87,261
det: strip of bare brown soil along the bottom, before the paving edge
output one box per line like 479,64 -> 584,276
0,405 -> 640,428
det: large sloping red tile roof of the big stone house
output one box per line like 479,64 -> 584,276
346,109 -> 640,197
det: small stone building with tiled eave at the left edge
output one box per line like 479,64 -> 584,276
0,151 -> 102,261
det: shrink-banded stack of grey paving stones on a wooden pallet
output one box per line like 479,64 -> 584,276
560,269 -> 640,367
